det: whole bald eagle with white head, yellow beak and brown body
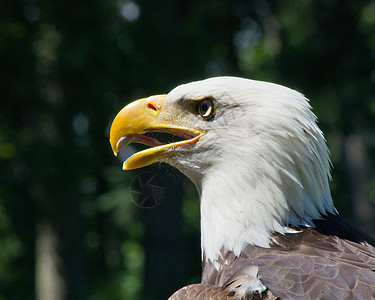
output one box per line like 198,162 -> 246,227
110,77 -> 375,300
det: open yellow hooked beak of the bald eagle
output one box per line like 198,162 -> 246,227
110,95 -> 203,170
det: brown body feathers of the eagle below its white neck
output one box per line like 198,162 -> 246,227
170,215 -> 375,300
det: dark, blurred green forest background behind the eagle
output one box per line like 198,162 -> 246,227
0,0 -> 375,300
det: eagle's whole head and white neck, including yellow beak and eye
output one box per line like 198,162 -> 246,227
110,77 -> 336,262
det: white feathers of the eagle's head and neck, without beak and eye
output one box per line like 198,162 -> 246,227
167,77 -> 336,263
